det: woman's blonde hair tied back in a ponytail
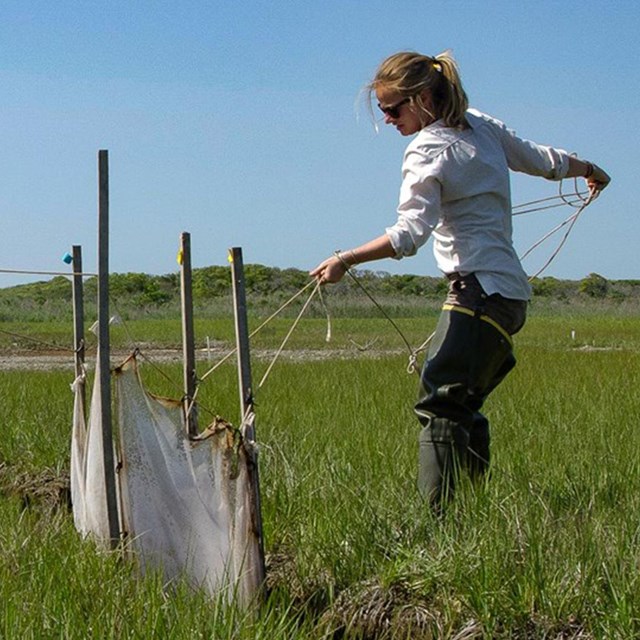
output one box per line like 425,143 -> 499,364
366,51 -> 469,129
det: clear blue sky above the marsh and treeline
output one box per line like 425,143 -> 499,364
0,0 -> 640,287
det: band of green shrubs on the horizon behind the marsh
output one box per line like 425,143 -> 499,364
0,264 -> 640,322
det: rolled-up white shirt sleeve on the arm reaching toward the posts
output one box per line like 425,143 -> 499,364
385,149 -> 441,259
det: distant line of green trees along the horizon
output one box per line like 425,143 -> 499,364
0,264 -> 640,322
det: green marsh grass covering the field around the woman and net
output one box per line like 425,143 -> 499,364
0,310 -> 640,639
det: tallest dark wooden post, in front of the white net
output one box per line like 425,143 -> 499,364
97,149 -> 120,549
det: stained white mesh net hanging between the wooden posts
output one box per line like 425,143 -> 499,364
71,356 -> 263,605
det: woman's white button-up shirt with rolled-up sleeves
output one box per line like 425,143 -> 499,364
386,109 -> 569,300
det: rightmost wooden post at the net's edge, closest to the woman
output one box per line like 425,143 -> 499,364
229,247 -> 266,584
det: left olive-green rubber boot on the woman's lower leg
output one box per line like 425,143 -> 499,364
418,418 -> 469,512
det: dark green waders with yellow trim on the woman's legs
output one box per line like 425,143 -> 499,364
415,305 -> 516,509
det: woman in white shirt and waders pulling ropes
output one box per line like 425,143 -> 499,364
311,52 -> 610,507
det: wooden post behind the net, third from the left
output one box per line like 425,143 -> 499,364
180,231 -> 198,436
